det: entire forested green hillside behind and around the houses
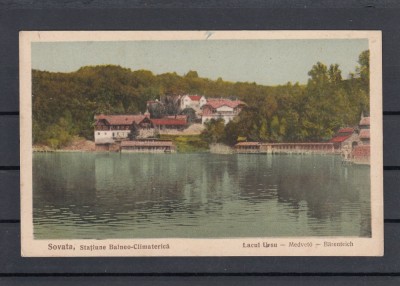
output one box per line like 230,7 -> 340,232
32,51 -> 369,148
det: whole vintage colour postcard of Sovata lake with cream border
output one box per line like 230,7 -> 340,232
20,31 -> 383,257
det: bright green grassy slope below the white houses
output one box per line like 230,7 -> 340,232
160,135 -> 209,153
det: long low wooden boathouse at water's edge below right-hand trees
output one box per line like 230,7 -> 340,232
235,142 -> 335,154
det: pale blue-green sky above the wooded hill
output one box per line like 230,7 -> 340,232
32,39 -> 368,85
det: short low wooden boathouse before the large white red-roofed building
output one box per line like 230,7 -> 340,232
120,139 -> 176,153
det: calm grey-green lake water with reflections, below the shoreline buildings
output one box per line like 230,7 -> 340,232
33,153 -> 371,239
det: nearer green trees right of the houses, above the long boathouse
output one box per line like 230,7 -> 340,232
203,51 -> 369,145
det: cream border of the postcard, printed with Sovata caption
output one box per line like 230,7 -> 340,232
20,31 -> 383,257
